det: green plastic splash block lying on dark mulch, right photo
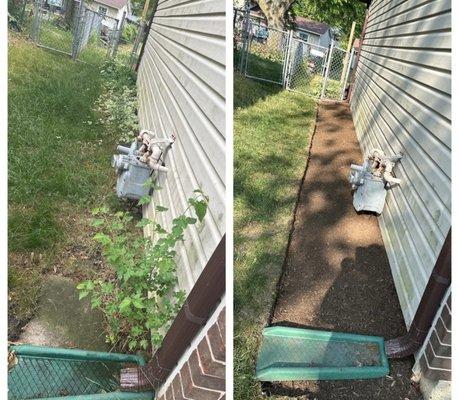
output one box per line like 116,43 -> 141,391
256,326 -> 389,382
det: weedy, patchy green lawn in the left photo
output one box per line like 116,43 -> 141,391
8,33 -> 116,336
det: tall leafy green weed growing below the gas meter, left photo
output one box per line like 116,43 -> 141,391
77,190 -> 209,351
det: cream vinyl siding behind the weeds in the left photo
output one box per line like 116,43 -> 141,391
138,0 -> 226,292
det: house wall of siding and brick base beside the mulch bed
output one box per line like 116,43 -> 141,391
350,0 -> 451,398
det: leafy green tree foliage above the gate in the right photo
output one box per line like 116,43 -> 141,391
291,0 -> 366,40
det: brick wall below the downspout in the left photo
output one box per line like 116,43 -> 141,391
159,308 -> 226,400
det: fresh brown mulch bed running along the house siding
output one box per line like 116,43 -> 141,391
266,103 -> 420,400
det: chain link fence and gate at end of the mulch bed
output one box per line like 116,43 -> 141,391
233,8 -> 354,100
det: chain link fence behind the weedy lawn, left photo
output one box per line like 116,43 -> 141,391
12,0 -> 147,68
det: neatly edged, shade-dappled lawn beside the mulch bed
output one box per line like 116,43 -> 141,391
234,73 -> 316,400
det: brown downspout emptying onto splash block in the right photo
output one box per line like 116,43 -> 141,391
385,228 -> 451,358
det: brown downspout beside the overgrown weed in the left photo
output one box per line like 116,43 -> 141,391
120,236 -> 225,390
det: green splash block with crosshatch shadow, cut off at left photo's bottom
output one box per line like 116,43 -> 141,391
8,345 -> 154,400
